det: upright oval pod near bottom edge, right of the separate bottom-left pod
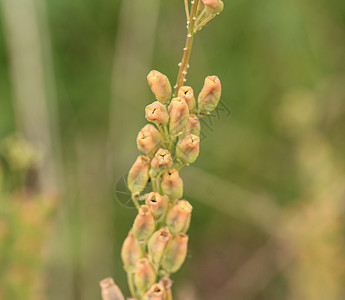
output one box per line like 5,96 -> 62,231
134,257 -> 156,295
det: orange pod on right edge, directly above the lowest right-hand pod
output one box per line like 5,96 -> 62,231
166,200 -> 193,234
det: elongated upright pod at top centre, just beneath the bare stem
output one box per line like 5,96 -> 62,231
169,97 -> 189,137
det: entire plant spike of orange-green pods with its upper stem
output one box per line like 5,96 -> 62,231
101,0 -> 224,300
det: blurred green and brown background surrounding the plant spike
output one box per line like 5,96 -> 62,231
0,0 -> 345,300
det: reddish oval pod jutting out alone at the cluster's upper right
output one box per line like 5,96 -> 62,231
198,76 -> 222,115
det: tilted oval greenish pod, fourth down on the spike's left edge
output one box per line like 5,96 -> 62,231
127,155 -> 151,195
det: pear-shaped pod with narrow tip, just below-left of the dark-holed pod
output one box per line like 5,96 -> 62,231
132,205 -> 155,241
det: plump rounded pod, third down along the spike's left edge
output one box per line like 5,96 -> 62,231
137,124 -> 162,157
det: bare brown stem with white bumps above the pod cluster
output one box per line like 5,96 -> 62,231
174,0 -> 199,95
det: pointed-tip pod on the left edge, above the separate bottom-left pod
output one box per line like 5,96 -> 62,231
121,231 -> 143,272
